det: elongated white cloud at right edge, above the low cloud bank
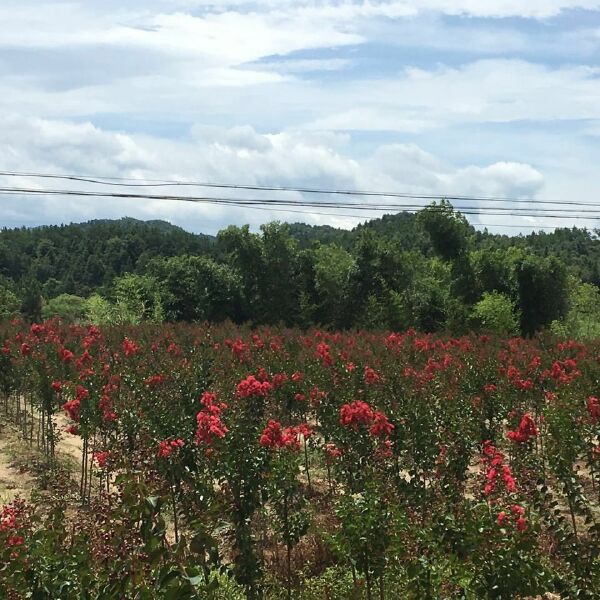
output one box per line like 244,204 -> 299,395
309,60 -> 600,132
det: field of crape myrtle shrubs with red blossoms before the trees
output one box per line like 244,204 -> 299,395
0,321 -> 600,599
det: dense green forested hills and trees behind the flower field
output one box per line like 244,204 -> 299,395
0,203 -> 600,334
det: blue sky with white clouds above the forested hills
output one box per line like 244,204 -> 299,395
0,0 -> 600,234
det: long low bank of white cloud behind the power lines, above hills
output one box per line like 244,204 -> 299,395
0,118 -> 556,233
